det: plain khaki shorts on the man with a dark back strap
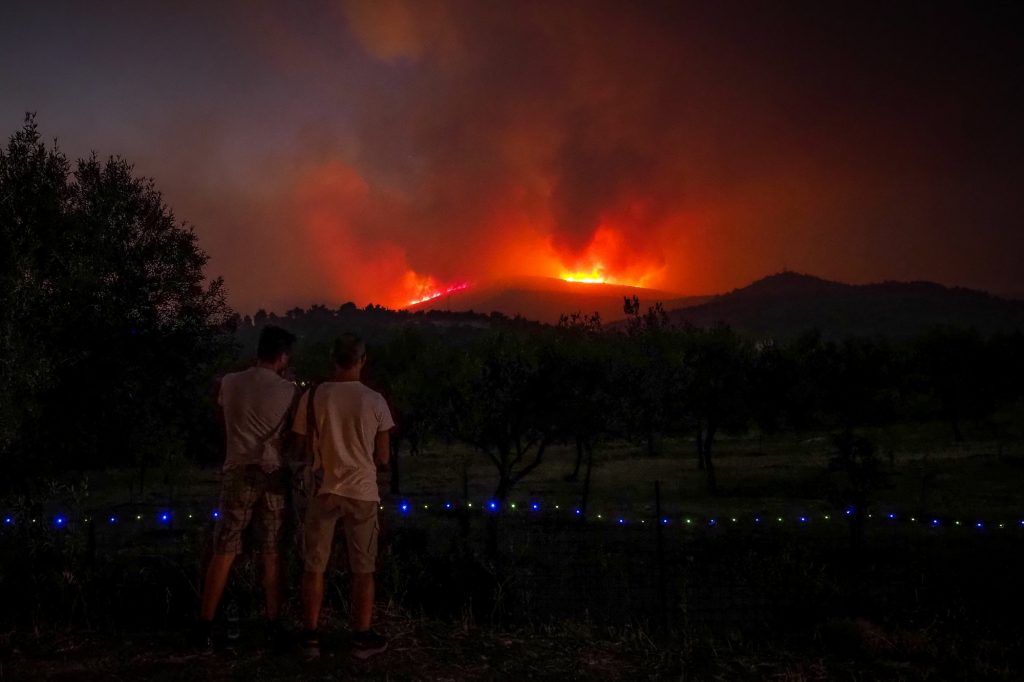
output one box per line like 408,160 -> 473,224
302,494 -> 380,573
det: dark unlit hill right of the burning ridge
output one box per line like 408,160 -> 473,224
669,272 -> 1024,338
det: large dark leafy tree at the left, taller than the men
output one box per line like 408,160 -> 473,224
0,116 -> 232,481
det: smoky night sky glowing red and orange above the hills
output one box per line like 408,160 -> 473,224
0,0 -> 1024,312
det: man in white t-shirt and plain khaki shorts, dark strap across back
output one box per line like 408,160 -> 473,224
292,334 -> 394,658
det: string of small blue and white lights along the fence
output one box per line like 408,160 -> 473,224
3,500 -> 1024,530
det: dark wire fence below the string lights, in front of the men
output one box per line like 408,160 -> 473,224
0,483 -> 1024,631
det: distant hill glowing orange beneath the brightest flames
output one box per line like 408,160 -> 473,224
409,278 -> 710,324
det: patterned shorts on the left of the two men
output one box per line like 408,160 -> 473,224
213,466 -> 288,554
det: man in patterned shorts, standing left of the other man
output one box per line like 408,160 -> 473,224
197,326 -> 295,646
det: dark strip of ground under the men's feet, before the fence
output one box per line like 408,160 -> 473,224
0,612 -> 1024,682
